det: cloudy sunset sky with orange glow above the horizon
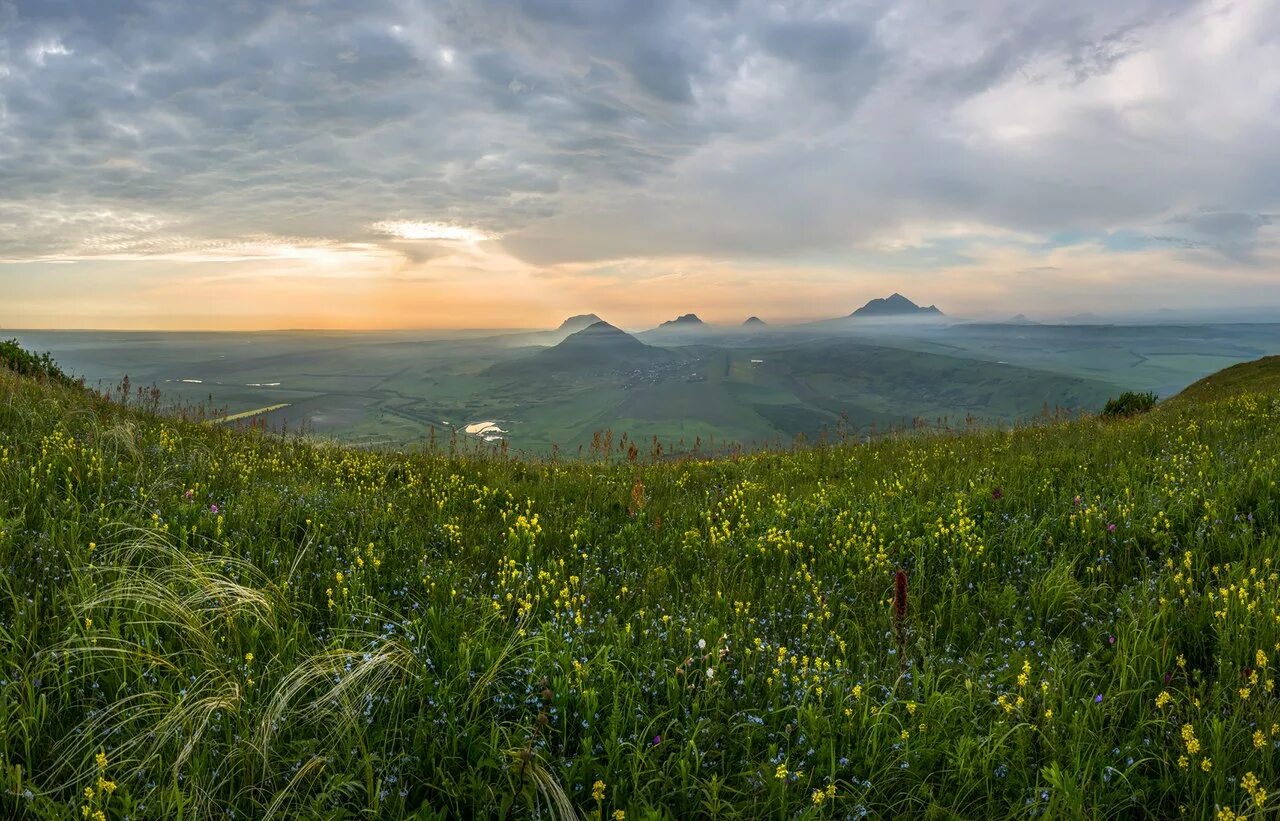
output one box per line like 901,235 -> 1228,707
0,0 -> 1280,329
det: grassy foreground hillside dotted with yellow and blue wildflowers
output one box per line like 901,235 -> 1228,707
0,360 -> 1280,818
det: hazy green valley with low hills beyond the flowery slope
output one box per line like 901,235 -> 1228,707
6,307 -> 1280,455
